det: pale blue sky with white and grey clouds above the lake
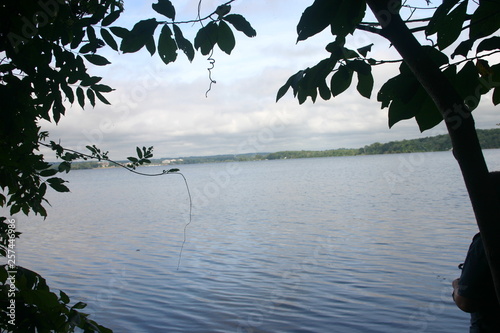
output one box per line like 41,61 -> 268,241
42,0 -> 500,159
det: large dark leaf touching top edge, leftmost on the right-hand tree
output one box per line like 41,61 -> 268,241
297,0 -> 340,42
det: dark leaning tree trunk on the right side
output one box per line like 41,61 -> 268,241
367,0 -> 500,302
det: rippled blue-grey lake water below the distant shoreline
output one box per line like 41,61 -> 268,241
8,150 -> 500,333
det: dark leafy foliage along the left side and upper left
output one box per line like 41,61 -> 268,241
0,0 -> 256,332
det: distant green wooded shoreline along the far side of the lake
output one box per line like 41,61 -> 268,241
72,129 -> 500,169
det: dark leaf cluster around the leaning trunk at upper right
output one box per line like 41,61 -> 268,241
277,0 -> 500,131
